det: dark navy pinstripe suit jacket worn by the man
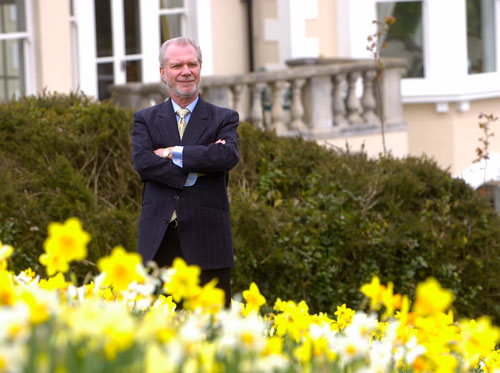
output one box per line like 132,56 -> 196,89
132,97 -> 239,270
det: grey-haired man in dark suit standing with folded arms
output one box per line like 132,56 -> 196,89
132,37 -> 239,306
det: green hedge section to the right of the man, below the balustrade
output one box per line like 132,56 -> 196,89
230,125 -> 500,321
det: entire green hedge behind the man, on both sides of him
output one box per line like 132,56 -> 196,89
0,95 -> 500,322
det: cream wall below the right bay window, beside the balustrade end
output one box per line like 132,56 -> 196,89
403,99 -> 500,174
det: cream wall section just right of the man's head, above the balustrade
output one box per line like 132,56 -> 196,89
210,0 -> 249,74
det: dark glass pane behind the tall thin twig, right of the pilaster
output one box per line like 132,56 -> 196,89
377,1 -> 424,78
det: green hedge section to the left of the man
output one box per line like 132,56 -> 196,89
0,94 -> 141,273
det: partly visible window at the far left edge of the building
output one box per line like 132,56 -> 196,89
0,0 -> 28,101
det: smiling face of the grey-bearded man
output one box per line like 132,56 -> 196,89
160,44 -> 201,99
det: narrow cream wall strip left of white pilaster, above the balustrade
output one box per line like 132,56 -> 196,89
306,0 -> 338,57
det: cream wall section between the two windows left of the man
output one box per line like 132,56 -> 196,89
33,0 -> 73,93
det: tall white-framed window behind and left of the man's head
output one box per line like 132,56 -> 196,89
74,0 -> 195,100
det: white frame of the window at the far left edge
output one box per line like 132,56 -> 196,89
0,0 -> 37,99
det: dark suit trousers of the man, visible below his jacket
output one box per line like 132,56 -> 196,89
153,220 -> 231,307
